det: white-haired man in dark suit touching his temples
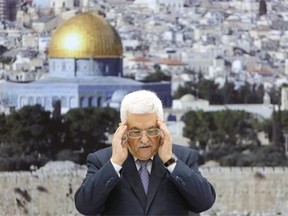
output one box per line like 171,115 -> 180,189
75,90 -> 216,215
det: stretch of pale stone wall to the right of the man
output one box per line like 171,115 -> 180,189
200,167 -> 288,216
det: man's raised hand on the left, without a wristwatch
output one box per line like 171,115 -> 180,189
111,123 -> 128,166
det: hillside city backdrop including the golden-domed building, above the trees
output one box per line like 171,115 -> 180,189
0,0 -> 288,118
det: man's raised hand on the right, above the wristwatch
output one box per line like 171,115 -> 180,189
157,120 -> 173,163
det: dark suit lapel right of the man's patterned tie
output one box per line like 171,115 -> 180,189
145,155 -> 166,213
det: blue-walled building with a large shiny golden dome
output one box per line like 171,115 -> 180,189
0,12 -> 171,113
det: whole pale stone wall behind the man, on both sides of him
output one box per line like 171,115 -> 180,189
0,162 -> 288,216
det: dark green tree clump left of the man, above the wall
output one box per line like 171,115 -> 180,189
0,105 -> 119,171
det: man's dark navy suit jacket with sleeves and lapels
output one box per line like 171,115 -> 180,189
75,145 -> 215,215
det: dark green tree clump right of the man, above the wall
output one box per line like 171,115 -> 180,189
183,110 -> 288,166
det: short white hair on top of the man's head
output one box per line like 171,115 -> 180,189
120,90 -> 164,122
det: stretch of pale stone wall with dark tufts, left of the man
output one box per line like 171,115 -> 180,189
0,162 -> 86,216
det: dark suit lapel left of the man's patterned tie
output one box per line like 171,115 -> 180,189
121,153 -> 146,209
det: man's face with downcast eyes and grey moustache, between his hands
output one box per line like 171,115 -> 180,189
126,113 -> 161,160
